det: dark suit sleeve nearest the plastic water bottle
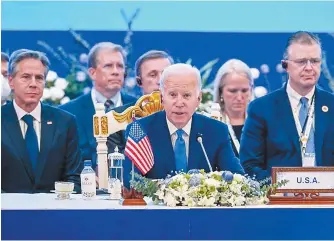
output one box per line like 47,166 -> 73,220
64,117 -> 83,192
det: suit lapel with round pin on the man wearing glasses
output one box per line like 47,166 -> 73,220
314,88 -> 329,165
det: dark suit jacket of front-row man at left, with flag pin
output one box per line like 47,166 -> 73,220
1,103 -> 83,192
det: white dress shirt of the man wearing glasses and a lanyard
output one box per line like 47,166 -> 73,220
286,81 -> 315,126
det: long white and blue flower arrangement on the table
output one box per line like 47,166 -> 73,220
131,169 -> 286,207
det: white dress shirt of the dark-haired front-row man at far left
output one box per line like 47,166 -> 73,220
13,100 -> 42,150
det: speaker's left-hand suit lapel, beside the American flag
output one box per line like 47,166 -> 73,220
149,111 -> 176,173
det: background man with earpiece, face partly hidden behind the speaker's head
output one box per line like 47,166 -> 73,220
107,50 -> 174,152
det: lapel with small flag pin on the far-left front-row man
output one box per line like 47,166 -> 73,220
36,104 -> 57,180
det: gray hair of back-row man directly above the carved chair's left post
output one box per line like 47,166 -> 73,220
88,42 -> 126,68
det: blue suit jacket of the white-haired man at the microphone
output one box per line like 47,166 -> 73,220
124,111 -> 244,186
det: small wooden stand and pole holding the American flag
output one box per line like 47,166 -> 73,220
121,162 -> 147,206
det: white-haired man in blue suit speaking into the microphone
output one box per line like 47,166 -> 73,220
124,64 -> 244,186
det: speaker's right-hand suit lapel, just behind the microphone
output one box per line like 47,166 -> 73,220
188,113 -> 205,170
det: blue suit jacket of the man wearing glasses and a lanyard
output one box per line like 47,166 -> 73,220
240,87 -> 334,180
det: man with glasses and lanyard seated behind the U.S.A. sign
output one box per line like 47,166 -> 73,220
240,32 -> 334,180
